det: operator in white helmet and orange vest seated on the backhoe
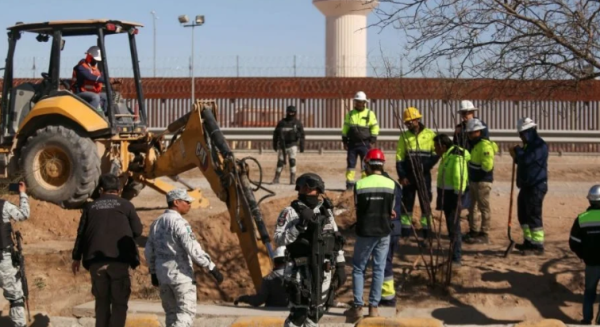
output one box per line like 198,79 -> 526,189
71,46 -> 111,112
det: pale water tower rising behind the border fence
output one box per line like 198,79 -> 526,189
313,0 -> 378,77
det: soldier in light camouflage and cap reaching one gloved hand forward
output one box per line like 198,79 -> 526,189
145,189 -> 223,327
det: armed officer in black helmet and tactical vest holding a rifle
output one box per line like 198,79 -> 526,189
274,173 -> 346,327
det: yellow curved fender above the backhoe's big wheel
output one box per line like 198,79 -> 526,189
19,95 -> 109,132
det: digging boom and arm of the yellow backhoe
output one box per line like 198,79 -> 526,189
145,105 -> 272,291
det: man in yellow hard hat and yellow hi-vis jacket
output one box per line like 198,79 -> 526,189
396,107 -> 439,238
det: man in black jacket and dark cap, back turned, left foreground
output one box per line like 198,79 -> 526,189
72,174 -> 142,327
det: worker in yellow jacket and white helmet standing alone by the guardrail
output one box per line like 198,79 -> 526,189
342,91 -> 379,190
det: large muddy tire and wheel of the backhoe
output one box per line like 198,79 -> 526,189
19,126 -> 101,209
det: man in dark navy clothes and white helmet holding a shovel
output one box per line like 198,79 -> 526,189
510,117 -> 548,254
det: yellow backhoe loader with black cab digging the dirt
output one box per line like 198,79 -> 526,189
0,19 -> 274,290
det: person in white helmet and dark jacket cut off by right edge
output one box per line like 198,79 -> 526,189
569,185 -> 600,325
